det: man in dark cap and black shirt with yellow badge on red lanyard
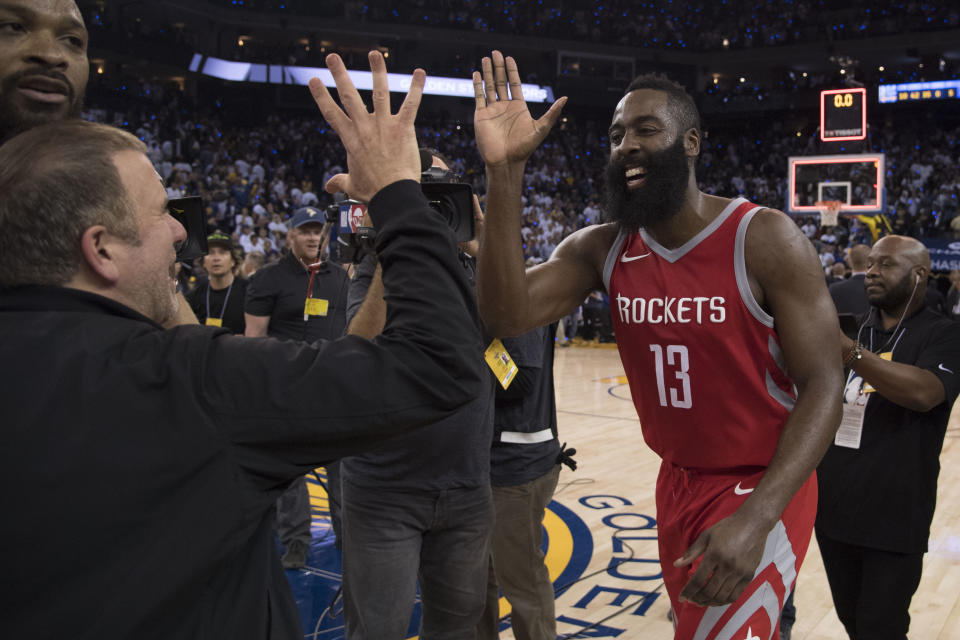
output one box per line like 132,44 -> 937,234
244,207 -> 350,569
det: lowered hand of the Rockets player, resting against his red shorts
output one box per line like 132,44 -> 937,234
674,513 -> 769,607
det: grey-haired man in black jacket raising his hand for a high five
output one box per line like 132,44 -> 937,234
0,51 -> 486,640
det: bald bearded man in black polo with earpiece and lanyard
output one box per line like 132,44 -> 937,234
816,236 -> 960,640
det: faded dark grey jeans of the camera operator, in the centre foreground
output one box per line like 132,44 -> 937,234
341,478 -> 493,640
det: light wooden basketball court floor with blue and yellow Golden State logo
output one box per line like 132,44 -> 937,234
287,345 -> 960,640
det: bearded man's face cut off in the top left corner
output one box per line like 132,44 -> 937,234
0,0 -> 90,144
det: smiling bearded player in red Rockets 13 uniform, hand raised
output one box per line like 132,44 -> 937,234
473,51 -> 843,640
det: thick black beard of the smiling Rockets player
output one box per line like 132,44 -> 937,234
603,137 -> 690,232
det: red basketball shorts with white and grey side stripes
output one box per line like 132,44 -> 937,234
657,462 -> 817,640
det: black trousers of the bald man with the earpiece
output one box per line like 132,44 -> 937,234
817,532 -> 923,640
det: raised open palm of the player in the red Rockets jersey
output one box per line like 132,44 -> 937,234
473,51 -> 567,167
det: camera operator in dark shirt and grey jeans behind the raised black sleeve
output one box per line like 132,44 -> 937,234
340,151 -> 493,640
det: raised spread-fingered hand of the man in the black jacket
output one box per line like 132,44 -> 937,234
310,51 -> 427,202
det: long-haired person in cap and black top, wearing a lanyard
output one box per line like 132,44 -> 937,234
187,231 -> 248,335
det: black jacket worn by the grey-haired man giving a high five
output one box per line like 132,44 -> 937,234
0,181 -> 485,640
